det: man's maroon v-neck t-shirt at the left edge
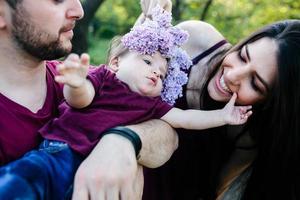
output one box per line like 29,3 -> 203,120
0,61 -> 63,165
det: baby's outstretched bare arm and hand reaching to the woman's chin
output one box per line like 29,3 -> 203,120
161,94 -> 252,130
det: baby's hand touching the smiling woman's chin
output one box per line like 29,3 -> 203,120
222,93 -> 252,125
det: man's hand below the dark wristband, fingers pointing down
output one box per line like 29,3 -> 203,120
72,134 -> 144,200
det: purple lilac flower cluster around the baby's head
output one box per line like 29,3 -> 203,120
122,6 -> 192,105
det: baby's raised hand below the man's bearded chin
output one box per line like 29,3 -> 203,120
55,54 -> 90,88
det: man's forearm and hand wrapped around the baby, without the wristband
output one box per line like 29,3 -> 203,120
73,120 -> 178,200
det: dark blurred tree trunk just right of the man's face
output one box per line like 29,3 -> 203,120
72,0 -> 105,54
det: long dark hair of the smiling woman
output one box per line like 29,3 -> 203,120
201,20 -> 300,200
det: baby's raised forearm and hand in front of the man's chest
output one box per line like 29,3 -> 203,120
55,54 -> 95,108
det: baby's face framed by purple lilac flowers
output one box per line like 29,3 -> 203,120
116,51 -> 168,97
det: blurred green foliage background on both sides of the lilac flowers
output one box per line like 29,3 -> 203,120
89,0 -> 300,64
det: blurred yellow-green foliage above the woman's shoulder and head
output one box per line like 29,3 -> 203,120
177,0 -> 300,43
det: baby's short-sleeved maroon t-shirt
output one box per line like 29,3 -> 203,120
40,66 -> 172,156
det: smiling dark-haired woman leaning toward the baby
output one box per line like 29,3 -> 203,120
142,1 -> 300,200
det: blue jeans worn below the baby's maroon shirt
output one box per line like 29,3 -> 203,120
0,140 -> 83,200
